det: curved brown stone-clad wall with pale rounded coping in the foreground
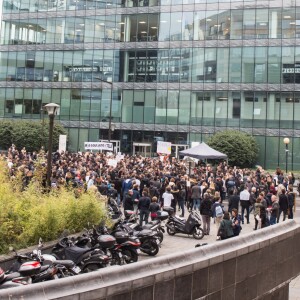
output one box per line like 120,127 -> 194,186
0,220 -> 300,300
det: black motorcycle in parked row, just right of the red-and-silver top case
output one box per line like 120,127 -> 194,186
51,236 -> 115,273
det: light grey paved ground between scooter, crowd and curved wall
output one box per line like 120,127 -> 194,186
140,197 -> 300,300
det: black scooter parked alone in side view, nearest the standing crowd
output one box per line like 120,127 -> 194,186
164,207 -> 204,240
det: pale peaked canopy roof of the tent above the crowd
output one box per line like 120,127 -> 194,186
179,142 -> 227,160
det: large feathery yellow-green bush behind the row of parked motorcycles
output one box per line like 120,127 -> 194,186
0,161 -> 109,253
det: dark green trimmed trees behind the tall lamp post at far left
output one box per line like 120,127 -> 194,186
0,120 -> 66,152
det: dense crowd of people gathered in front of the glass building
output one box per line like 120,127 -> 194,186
2,145 -> 295,239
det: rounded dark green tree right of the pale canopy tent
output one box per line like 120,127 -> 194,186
207,130 -> 259,168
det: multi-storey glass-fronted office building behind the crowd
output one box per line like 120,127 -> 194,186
0,0 -> 300,170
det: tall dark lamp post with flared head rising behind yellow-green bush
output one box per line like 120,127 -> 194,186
44,103 -> 60,189
